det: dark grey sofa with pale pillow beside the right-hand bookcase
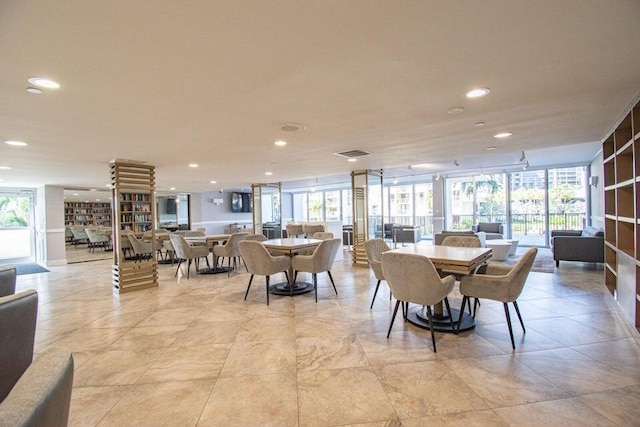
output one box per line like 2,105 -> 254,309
551,227 -> 604,267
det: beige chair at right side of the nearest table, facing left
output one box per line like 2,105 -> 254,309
458,248 -> 538,350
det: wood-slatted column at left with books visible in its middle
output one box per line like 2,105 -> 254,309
111,160 -> 158,293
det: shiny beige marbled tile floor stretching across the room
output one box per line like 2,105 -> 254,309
13,249 -> 640,426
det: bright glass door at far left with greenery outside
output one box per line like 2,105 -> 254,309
0,192 -> 35,263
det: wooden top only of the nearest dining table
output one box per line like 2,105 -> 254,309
392,244 -> 492,274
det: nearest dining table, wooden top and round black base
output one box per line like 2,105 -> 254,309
392,244 -> 492,332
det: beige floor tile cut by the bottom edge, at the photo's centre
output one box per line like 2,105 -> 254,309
298,368 -> 397,426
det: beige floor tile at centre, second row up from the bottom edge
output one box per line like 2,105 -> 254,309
296,335 -> 369,371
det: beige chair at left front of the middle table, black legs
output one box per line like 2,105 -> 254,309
238,239 -> 291,305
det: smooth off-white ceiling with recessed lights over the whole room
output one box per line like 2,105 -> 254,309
0,0 -> 640,195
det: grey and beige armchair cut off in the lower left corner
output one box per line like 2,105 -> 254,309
0,290 -> 73,427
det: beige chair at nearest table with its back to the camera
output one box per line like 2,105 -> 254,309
382,251 -> 456,353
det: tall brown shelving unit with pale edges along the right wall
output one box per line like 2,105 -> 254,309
602,97 -> 640,328
